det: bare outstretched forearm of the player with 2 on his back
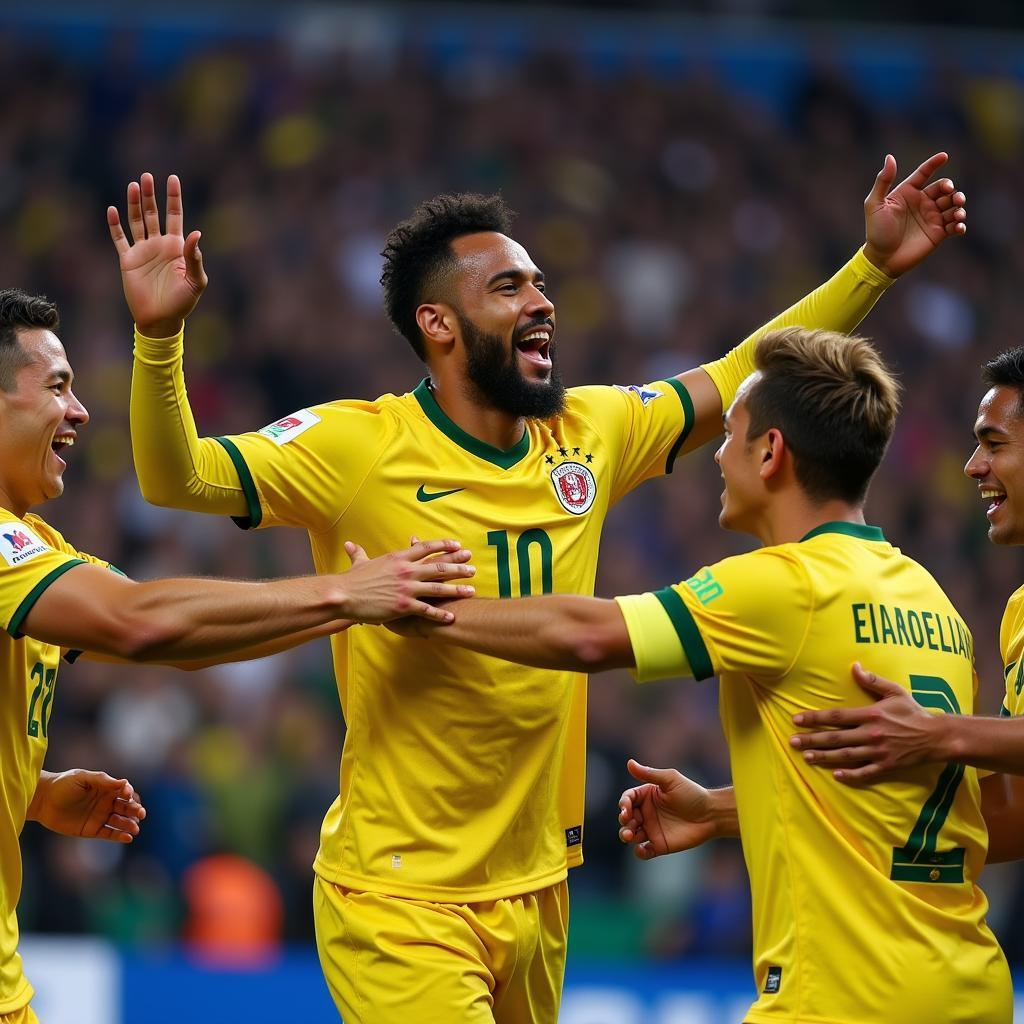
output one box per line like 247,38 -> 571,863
422,594 -> 634,672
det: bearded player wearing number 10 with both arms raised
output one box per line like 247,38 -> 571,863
114,154 -> 966,1024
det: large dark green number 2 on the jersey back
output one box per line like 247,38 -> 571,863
889,676 -> 965,883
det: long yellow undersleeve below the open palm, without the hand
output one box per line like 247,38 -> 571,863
130,331 -> 248,516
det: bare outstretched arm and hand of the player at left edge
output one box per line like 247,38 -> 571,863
22,541 -> 474,663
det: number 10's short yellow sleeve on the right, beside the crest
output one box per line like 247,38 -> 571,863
569,378 -> 694,502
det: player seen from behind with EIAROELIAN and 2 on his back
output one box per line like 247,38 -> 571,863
400,328 -> 1012,1024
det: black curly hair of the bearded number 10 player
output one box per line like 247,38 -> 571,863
381,193 -> 515,359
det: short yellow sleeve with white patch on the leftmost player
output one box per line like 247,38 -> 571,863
0,517 -> 85,640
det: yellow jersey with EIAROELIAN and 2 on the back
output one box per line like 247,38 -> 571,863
621,523 -> 1012,1024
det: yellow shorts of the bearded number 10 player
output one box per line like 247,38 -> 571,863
313,876 -> 568,1024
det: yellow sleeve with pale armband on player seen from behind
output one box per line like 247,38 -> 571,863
623,547 -> 814,681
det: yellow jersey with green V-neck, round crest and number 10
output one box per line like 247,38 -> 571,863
220,381 -> 692,902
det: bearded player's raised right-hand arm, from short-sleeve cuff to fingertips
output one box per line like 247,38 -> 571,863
679,153 -> 967,452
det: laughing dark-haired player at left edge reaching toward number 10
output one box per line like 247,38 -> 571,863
0,290 -> 472,1024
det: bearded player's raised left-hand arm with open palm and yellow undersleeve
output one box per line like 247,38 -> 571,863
106,174 -> 248,516
